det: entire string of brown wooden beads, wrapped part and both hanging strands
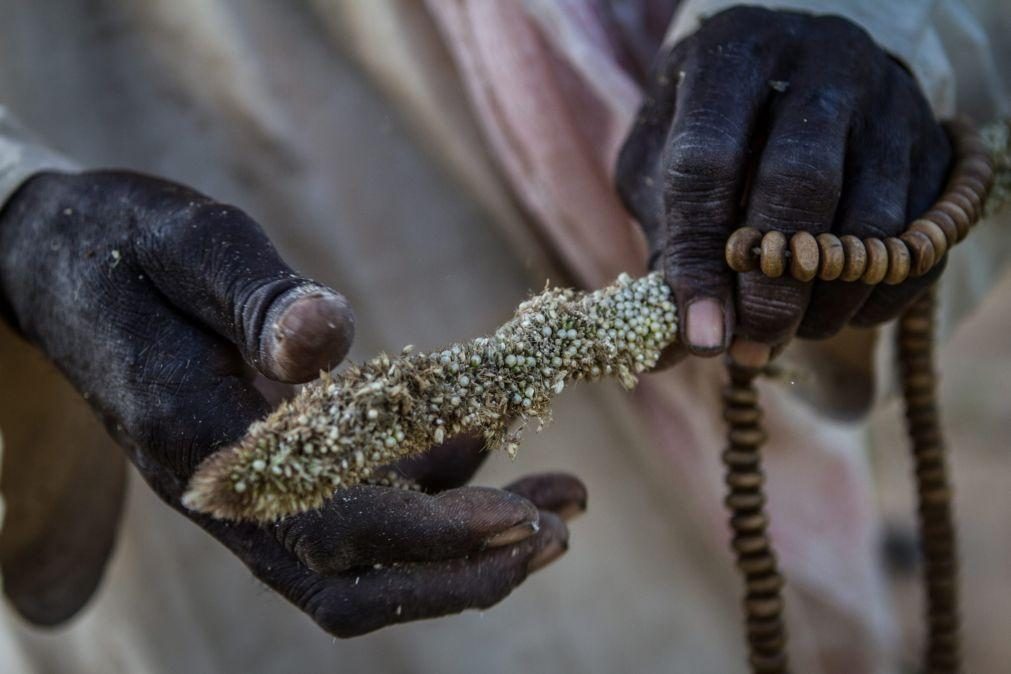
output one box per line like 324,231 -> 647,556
723,121 -> 994,674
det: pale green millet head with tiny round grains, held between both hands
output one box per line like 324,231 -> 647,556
183,273 -> 677,521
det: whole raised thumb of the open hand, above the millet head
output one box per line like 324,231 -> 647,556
137,189 -> 355,383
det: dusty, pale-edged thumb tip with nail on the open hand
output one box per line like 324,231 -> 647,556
264,288 -> 355,383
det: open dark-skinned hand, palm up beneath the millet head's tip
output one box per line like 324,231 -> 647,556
0,172 -> 585,637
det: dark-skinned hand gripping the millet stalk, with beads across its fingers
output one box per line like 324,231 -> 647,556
617,7 -> 951,362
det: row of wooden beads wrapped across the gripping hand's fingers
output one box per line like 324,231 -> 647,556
725,120 -> 994,285
